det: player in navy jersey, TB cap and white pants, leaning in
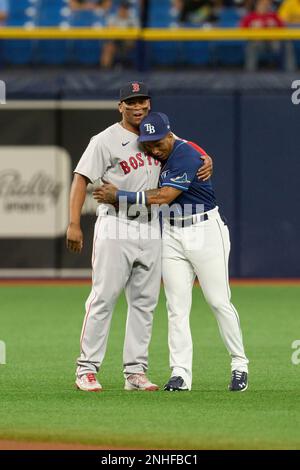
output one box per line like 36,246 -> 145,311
94,113 -> 248,391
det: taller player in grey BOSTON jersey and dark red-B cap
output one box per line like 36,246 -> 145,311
67,82 -> 211,391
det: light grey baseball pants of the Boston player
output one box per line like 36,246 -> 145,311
77,215 -> 161,375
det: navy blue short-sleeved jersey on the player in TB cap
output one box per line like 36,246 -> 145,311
159,139 -> 216,215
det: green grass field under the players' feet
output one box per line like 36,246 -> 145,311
0,285 -> 300,449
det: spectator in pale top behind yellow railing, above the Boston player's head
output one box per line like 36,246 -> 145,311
100,1 -> 139,69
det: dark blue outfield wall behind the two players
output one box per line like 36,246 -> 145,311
0,74 -> 300,278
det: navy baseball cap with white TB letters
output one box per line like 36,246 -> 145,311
138,113 -> 171,142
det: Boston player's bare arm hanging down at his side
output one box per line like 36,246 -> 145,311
67,173 -> 90,253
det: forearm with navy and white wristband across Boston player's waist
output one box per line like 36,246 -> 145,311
93,183 -> 182,206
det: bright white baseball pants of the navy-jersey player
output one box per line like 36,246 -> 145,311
162,207 -> 249,389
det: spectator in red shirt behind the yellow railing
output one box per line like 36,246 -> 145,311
241,0 -> 296,72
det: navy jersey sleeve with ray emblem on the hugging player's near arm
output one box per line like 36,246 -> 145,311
160,144 -> 203,191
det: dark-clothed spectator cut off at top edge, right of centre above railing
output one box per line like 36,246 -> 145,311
173,0 -> 218,25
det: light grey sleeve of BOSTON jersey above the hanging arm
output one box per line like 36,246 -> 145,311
74,136 -> 110,183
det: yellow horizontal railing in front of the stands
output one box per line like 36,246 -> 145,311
0,26 -> 300,70
